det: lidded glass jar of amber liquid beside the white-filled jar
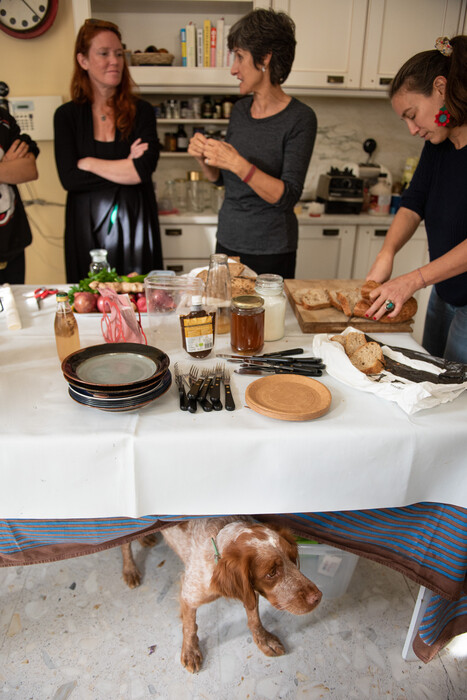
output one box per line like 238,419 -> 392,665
230,295 -> 264,355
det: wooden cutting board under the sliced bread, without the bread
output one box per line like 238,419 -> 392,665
284,280 -> 413,333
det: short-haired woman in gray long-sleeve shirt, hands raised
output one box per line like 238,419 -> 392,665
188,9 -> 317,278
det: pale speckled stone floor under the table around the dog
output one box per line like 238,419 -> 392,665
0,541 -> 467,700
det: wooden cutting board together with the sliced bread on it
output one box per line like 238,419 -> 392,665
284,279 -> 417,333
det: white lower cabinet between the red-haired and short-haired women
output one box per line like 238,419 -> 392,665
160,221 -> 217,274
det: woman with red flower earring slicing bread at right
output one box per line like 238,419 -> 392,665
367,36 -> 467,362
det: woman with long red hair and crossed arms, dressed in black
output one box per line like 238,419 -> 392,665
54,19 -> 162,282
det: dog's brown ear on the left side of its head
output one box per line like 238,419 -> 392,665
211,550 -> 256,610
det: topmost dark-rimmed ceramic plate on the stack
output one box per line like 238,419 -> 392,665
62,343 -> 169,389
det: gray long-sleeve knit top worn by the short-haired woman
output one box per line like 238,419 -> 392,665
217,96 -> 317,255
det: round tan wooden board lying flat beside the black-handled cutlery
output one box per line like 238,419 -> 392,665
245,374 -> 331,421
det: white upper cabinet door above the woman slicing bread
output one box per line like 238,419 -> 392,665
361,0 -> 462,91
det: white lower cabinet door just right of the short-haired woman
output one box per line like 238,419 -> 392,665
295,223 -> 357,279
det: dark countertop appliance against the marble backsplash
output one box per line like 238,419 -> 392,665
316,167 -> 363,214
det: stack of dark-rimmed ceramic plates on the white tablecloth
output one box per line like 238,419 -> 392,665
62,343 -> 172,411
